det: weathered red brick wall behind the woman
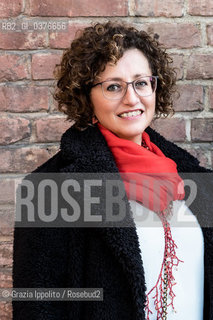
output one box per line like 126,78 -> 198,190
0,0 -> 213,320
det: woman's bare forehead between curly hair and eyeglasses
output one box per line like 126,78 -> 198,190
99,49 -> 151,79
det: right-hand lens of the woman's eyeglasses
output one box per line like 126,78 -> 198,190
134,77 -> 156,97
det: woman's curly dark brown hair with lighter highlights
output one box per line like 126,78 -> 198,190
53,21 -> 176,129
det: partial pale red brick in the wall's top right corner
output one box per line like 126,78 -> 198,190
188,0 -> 213,16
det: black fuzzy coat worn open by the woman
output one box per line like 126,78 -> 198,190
13,126 -> 213,320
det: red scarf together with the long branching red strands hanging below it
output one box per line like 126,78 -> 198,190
98,123 -> 185,320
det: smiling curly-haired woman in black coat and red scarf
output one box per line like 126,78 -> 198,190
13,22 -> 213,320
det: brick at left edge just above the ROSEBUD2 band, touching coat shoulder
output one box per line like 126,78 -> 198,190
0,147 -> 55,173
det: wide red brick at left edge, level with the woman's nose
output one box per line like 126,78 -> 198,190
0,86 -> 48,112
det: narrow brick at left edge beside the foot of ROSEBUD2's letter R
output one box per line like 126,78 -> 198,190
0,206 -> 15,236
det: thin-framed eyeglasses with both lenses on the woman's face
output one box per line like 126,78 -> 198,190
92,76 -> 158,100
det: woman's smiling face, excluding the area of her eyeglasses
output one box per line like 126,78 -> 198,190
91,49 -> 155,144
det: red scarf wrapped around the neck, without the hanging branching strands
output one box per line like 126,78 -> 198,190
98,123 -> 185,212
